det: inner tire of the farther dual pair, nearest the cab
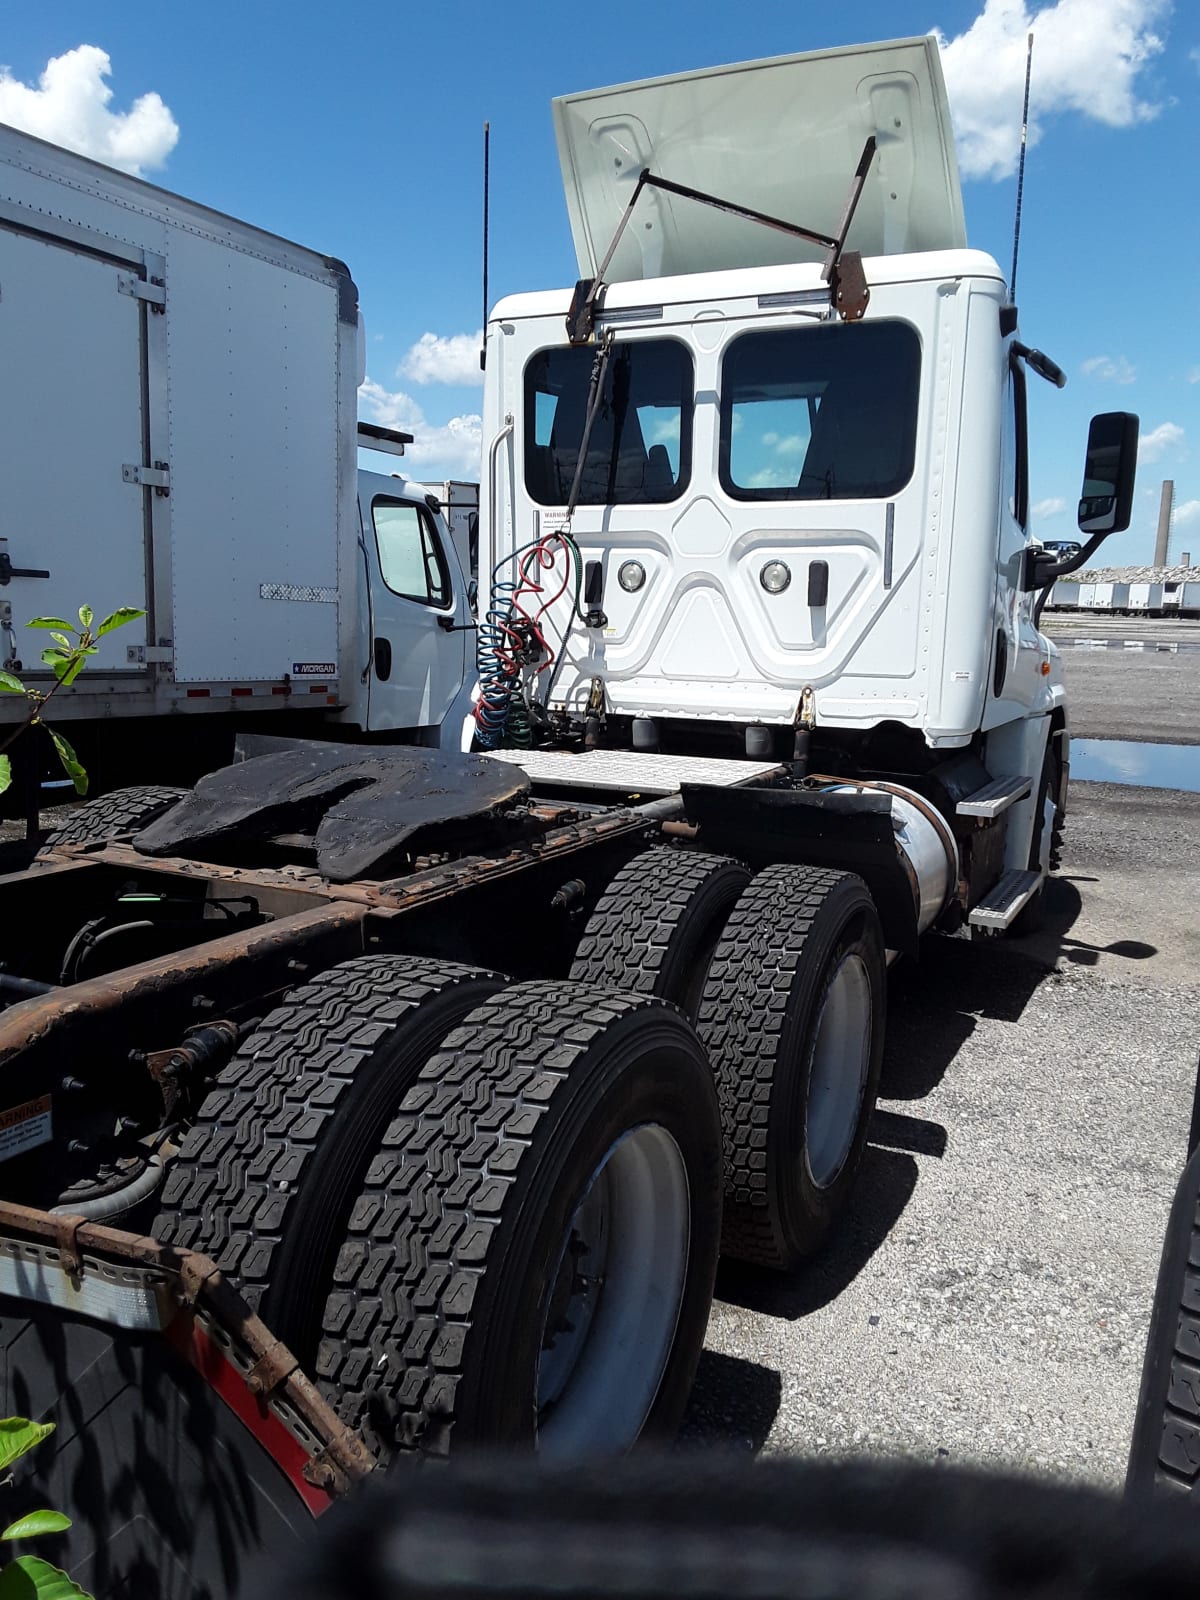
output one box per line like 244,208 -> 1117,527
571,846 -> 750,1021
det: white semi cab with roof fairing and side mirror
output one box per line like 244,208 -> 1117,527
477,38 -> 1136,931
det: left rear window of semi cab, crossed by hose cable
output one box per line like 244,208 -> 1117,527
525,339 -> 693,506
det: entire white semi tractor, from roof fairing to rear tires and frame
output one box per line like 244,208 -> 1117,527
0,31 -> 1136,1592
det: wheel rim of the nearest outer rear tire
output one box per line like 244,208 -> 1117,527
534,1123 -> 691,1458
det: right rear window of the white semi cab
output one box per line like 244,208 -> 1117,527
720,322 -> 920,501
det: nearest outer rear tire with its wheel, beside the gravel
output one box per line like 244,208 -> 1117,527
317,981 -> 722,1459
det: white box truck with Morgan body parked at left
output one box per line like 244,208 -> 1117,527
0,128 -> 472,790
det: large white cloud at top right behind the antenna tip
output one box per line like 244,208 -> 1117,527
936,0 -> 1170,179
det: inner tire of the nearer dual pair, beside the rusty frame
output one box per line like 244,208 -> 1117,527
154,955 -> 504,1368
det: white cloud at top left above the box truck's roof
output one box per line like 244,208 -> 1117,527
0,45 -> 179,176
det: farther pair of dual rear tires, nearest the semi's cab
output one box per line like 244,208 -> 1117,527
571,848 -> 886,1270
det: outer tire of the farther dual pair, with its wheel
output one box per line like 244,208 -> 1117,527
698,866 -> 886,1270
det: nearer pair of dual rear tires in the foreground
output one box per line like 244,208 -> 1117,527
154,957 -> 722,1459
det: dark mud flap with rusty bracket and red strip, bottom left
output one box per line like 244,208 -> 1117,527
0,1203 -> 371,1600
